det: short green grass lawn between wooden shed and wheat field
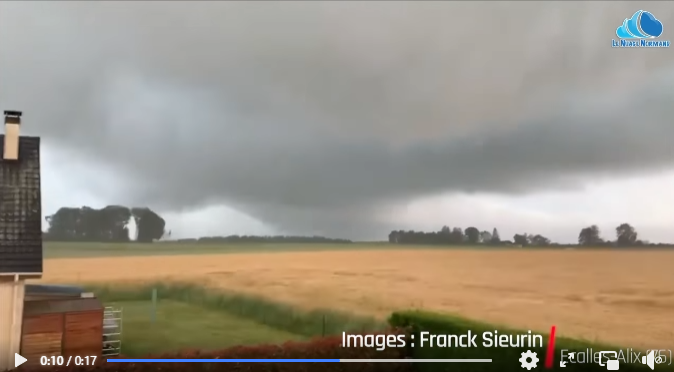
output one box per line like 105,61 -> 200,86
106,300 -> 303,357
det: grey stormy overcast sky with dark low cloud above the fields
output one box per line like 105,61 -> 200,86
0,1 -> 674,242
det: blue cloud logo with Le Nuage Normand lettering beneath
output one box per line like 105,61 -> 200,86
611,10 -> 670,48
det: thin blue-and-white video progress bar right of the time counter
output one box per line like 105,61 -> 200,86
108,359 -> 491,363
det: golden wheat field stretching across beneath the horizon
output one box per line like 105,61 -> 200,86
43,249 -> 674,349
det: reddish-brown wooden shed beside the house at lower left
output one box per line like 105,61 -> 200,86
20,284 -> 104,364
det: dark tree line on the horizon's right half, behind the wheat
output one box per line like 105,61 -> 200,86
388,223 -> 671,247
